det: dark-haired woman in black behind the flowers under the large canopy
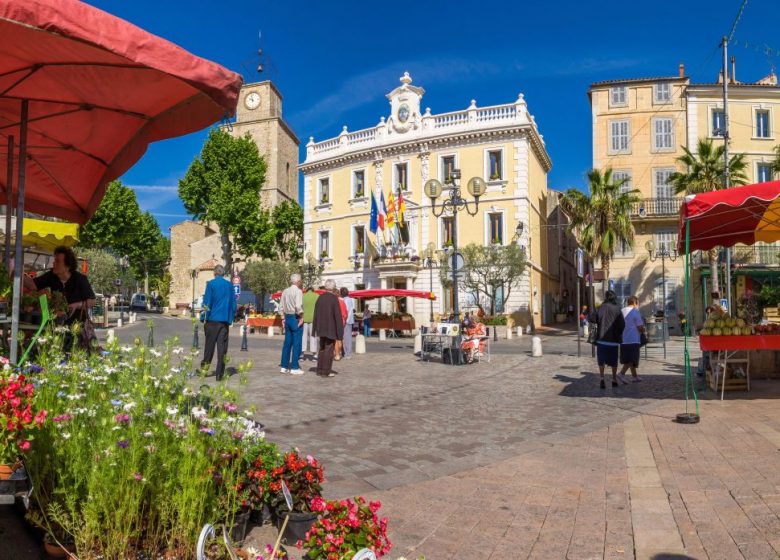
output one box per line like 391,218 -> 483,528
23,246 -> 96,351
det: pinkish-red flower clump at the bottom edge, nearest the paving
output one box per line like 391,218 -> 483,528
302,496 -> 392,560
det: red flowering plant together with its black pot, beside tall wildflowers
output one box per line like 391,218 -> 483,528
268,450 -> 325,543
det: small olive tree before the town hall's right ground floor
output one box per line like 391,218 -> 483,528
461,243 -> 526,316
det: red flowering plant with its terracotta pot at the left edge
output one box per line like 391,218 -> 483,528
0,372 -> 46,494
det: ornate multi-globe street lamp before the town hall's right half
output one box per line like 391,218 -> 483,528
425,169 -> 487,320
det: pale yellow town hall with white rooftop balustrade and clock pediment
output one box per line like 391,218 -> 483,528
301,77 -> 558,325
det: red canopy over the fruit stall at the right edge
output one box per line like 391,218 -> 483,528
677,181 -> 780,253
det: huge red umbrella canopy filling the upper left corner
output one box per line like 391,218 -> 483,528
0,0 -> 242,223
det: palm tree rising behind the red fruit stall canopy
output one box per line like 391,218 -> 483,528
669,138 -> 748,292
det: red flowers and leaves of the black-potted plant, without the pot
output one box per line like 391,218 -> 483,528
268,451 -> 325,512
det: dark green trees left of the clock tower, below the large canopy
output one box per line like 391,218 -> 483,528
79,181 -> 170,291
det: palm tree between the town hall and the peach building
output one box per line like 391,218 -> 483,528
561,167 -> 639,296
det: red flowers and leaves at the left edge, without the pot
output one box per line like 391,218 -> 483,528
0,375 -> 46,464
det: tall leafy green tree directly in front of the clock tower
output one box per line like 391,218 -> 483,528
179,129 -> 270,273
